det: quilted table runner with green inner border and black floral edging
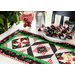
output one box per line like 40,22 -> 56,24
0,30 -> 75,64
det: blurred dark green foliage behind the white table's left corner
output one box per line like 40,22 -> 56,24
0,11 -> 24,34
